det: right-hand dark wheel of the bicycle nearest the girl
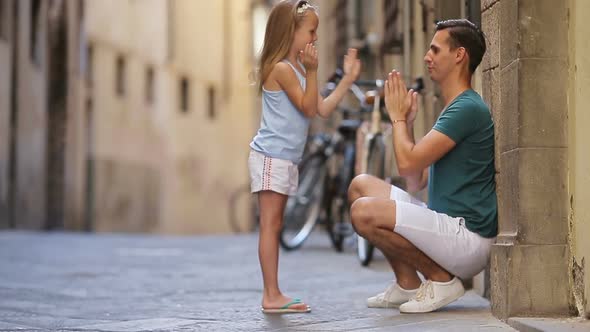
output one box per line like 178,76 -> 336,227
326,144 -> 354,252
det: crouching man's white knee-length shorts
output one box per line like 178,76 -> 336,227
390,186 -> 495,279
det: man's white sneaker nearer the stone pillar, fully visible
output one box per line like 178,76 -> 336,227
399,277 -> 465,313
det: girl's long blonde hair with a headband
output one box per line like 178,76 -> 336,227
257,0 -> 316,92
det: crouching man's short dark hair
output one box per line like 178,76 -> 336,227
436,19 -> 486,73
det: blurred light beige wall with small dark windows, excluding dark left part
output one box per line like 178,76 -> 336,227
86,0 -> 257,234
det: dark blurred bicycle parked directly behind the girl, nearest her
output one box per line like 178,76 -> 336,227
279,70 -> 367,252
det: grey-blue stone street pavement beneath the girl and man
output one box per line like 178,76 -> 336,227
0,231 -> 532,332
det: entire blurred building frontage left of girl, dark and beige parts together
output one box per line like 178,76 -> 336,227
0,0 -> 265,234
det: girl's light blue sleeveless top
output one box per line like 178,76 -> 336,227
250,60 -> 309,164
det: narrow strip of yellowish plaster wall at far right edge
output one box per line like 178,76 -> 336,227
568,0 -> 590,317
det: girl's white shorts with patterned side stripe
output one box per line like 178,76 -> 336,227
248,150 -> 299,195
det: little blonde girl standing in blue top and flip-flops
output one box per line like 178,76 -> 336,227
248,0 -> 361,313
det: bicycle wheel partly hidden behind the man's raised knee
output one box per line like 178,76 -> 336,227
357,135 -> 385,266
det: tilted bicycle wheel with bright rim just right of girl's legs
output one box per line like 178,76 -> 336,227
279,153 -> 326,250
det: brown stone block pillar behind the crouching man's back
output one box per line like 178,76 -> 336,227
482,0 -> 572,318
